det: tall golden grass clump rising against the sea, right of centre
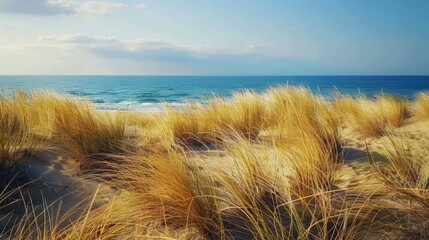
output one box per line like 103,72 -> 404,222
264,87 -> 339,145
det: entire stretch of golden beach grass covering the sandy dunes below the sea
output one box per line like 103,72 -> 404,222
0,86 -> 429,239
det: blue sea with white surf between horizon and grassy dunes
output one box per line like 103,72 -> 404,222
0,76 -> 429,111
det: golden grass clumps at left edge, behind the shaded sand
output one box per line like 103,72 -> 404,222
0,92 -> 127,171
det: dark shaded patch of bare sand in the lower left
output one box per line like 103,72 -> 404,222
0,149 -> 114,238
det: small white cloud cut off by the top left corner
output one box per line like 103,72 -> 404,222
0,0 -> 126,16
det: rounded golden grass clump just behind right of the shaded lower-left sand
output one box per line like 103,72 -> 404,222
54,98 -> 126,168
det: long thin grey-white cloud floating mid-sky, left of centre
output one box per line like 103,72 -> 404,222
38,34 -> 261,61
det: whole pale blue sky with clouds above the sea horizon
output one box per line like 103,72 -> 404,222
0,0 -> 429,75
